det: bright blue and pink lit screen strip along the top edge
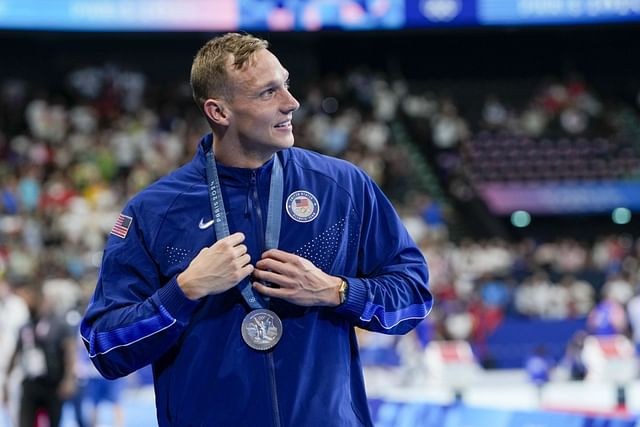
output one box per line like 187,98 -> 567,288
0,0 -> 640,32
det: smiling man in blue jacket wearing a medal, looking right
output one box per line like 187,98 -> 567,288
81,34 -> 432,427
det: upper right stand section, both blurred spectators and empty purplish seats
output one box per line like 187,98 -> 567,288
404,73 -> 640,192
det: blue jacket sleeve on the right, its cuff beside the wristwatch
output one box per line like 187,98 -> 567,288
336,172 -> 433,334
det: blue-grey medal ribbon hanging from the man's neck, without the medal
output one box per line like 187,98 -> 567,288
207,148 -> 284,310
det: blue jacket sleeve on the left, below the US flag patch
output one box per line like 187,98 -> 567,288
80,207 -> 197,378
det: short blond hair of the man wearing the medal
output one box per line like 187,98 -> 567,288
191,33 -> 269,110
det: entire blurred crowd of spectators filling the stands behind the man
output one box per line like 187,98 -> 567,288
0,59 -> 640,424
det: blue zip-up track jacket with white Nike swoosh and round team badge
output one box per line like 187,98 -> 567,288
81,135 -> 432,427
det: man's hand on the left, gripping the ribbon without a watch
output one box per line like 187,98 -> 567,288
177,233 -> 253,300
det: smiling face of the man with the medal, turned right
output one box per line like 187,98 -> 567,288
227,49 -> 300,155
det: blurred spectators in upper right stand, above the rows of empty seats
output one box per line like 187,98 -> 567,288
403,72 -> 640,149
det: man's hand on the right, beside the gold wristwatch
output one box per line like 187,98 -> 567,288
253,249 -> 342,307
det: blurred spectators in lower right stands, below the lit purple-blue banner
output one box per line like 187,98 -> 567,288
423,235 -> 640,344
